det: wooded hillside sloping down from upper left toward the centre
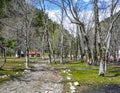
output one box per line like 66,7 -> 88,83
0,0 -> 72,55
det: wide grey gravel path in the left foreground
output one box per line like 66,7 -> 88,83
0,63 -> 63,93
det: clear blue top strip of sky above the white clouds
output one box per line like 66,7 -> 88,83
26,0 -> 120,11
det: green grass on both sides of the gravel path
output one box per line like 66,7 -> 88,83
0,58 -> 120,93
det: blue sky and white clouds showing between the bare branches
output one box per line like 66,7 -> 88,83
27,0 -> 120,33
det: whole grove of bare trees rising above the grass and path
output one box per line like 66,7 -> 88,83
0,0 -> 120,76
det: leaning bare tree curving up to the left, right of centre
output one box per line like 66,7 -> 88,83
63,0 -> 91,63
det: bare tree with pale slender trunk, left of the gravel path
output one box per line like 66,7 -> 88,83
1,0 -> 35,69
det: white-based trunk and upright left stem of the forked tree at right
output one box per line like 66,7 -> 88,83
94,0 -> 107,76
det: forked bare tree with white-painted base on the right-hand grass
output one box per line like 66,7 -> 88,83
94,0 -> 120,76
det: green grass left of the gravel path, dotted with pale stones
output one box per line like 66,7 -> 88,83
0,57 -> 40,83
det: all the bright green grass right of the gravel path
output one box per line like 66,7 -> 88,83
52,61 -> 120,93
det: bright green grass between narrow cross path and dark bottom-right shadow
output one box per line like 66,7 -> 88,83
70,70 -> 120,91
